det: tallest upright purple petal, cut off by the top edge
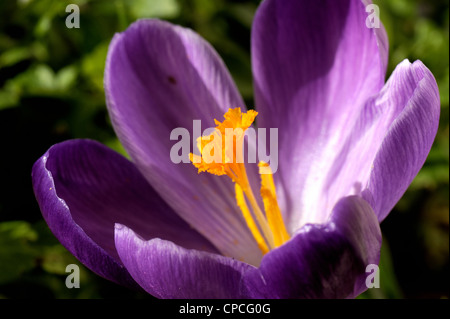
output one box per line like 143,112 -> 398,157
252,0 -> 388,231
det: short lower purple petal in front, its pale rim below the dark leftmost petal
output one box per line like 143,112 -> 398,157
115,224 -> 253,299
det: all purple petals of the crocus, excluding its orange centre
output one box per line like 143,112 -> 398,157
32,0 -> 440,298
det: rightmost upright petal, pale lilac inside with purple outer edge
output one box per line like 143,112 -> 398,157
299,60 -> 440,224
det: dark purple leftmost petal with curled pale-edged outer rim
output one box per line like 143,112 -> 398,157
32,140 -> 216,287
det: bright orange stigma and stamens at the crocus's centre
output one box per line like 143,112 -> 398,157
189,108 -> 290,254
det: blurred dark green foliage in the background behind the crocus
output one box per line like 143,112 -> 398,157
0,0 -> 449,298
